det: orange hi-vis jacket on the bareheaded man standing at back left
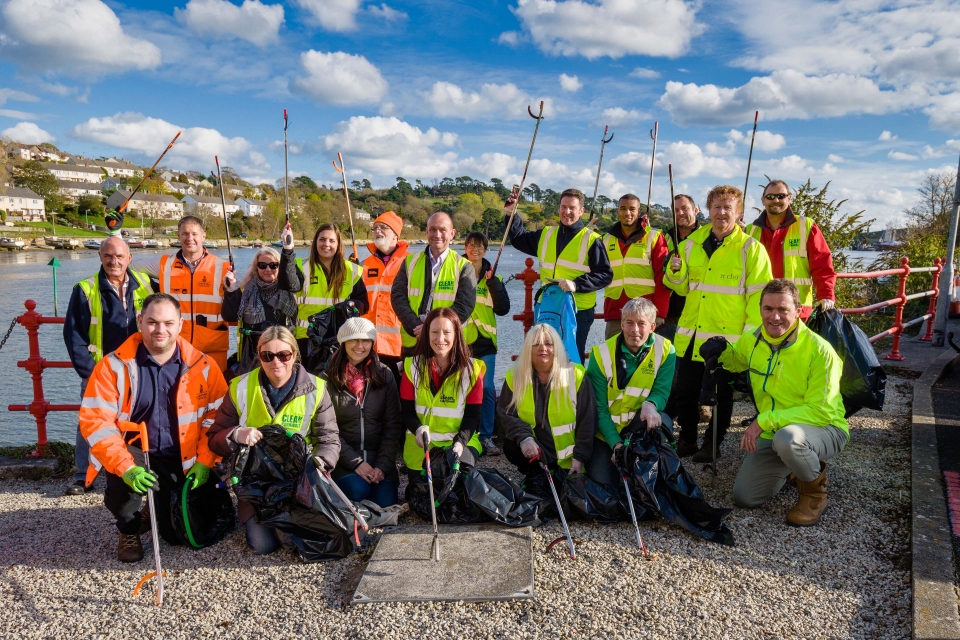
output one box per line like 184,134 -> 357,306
160,253 -> 230,371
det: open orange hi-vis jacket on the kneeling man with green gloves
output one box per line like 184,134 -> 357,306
80,333 -> 227,486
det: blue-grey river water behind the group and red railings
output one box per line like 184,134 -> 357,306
0,246 -> 603,445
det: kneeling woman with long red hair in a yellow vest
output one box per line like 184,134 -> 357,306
400,307 -> 484,475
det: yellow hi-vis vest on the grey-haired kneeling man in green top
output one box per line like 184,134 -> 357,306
591,334 -> 670,430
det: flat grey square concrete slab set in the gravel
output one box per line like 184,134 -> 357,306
352,524 -> 534,604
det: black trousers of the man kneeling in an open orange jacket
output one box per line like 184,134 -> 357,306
103,445 -> 189,545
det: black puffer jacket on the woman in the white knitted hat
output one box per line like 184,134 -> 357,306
323,363 -> 404,482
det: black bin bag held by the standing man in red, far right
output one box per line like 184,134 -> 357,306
807,309 -> 887,417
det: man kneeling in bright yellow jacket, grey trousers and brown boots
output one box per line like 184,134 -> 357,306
700,279 -> 850,526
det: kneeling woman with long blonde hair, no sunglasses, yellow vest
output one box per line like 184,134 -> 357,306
497,324 -> 597,477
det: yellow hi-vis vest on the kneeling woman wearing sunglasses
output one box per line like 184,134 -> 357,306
230,367 -> 325,444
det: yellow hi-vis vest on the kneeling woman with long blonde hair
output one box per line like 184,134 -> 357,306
506,364 -> 586,469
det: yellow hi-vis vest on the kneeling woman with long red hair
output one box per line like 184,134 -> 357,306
403,358 -> 484,471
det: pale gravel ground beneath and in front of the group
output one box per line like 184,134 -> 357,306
0,378 -> 912,639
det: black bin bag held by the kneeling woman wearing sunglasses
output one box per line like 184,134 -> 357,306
234,425 -> 369,562
